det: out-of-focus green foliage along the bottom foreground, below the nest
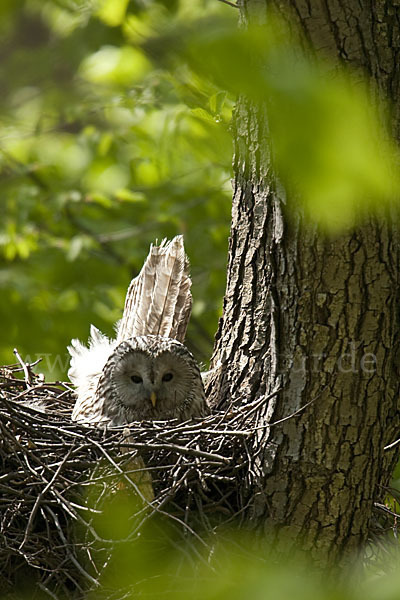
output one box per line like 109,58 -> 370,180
80,490 -> 400,600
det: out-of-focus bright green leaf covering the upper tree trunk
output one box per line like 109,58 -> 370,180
148,18 -> 400,232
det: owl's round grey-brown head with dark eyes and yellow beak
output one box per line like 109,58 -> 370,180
96,335 -> 206,424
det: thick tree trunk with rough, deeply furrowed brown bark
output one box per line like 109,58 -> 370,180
211,0 -> 400,564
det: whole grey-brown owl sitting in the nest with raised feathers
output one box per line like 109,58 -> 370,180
68,236 -> 209,425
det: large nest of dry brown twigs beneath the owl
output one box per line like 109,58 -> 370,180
0,355 -> 265,598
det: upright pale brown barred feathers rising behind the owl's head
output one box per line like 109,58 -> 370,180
117,235 -> 192,343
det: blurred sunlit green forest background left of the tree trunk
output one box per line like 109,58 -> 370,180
0,0 -> 232,380
